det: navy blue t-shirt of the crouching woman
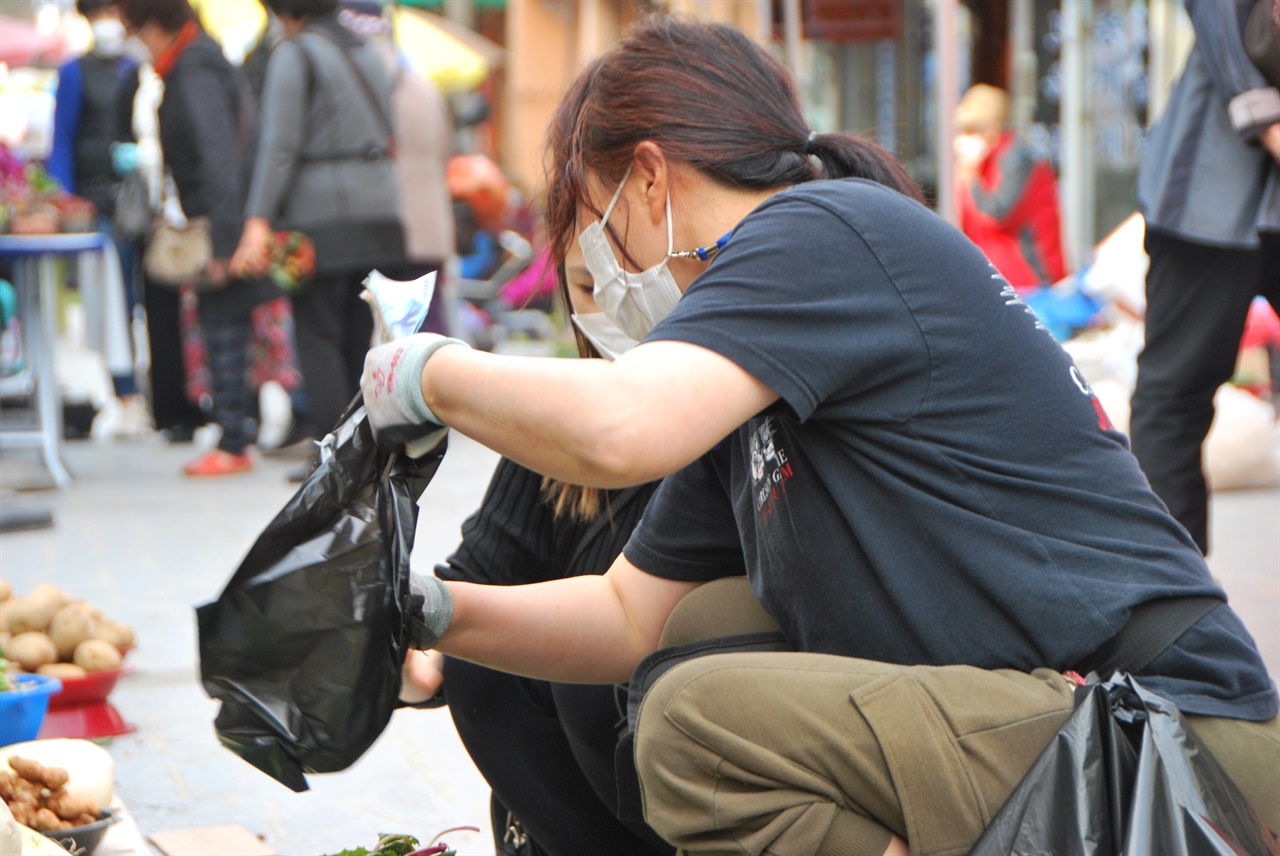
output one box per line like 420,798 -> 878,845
625,179 -> 1277,719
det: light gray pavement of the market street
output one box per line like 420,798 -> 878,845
0,435 -> 1280,856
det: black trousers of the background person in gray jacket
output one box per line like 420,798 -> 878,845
293,270 -> 374,436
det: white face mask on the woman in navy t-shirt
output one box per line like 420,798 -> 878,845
577,169 -> 680,339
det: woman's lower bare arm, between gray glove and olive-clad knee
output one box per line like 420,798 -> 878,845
435,555 -> 701,683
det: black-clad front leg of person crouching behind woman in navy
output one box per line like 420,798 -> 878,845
444,658 -> 662,856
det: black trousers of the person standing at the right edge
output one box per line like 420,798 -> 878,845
1129,229 -> 1280,554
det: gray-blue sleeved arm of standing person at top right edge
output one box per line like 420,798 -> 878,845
1187,0 -> 1280,142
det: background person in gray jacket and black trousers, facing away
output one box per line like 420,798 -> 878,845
233,0 -> 404,434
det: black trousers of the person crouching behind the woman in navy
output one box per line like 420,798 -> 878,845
444,658 -> 675,856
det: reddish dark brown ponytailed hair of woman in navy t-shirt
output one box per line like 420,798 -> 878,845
547,14 -> 923,269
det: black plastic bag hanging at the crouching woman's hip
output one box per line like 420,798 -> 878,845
970,673 -> 1280,856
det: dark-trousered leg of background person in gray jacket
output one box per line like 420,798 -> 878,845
293,274 -> 353,435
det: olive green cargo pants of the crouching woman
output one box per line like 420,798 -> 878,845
636,580 -> 1280,856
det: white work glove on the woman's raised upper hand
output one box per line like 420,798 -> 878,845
360,333 -> 470,457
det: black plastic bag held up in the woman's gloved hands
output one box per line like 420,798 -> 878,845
196,395 -> 445,791
